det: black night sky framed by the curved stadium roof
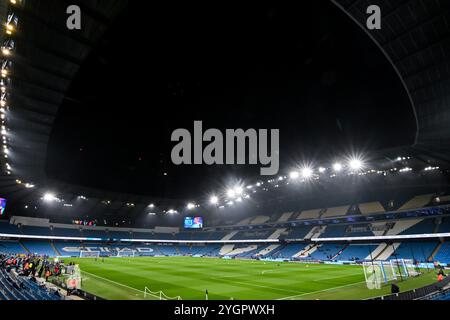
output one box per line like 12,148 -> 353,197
47,1 -> 416,198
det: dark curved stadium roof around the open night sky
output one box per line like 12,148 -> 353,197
0,0 -> 450,215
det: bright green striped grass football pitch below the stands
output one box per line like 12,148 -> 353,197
65,257 -> 436,300
